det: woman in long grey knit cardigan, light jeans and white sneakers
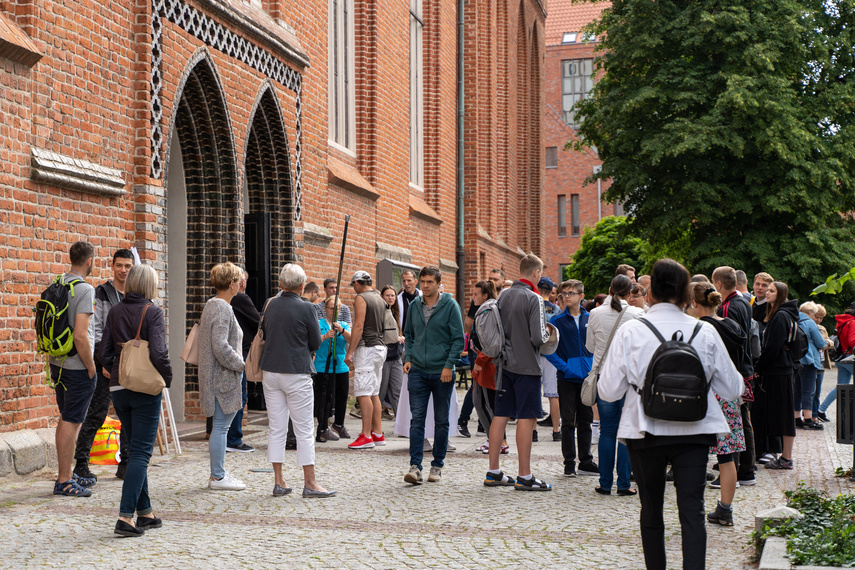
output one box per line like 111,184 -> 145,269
198,262 -> 246,491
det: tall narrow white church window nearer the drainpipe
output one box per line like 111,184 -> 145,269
410,0 -> 425,188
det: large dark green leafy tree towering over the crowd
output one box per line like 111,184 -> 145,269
568,0 -> 855,298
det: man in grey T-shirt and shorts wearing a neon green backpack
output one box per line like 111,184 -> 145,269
36,241 -> 97,497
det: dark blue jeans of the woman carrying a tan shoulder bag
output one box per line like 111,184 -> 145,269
111,390 -> 162,518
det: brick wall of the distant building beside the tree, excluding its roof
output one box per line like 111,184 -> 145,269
543,39 -> 614,281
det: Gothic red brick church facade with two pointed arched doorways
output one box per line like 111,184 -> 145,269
0,0 -> 545,431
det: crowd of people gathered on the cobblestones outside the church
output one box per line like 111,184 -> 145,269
36,242 -> 855,568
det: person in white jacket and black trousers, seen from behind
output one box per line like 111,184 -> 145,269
598,259 -> 742,568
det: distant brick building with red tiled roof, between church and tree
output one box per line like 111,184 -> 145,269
543,0 -> 615,281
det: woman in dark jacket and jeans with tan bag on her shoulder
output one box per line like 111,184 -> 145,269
101,265 -> 172,536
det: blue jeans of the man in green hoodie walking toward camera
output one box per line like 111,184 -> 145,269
407,368 -> 454,469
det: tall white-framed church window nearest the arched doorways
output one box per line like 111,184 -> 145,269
328,0 -> 356,152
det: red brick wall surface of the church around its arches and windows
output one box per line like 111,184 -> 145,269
0,0 -> 545,431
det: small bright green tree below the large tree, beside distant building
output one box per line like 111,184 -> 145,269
564,216 -> 647,292
